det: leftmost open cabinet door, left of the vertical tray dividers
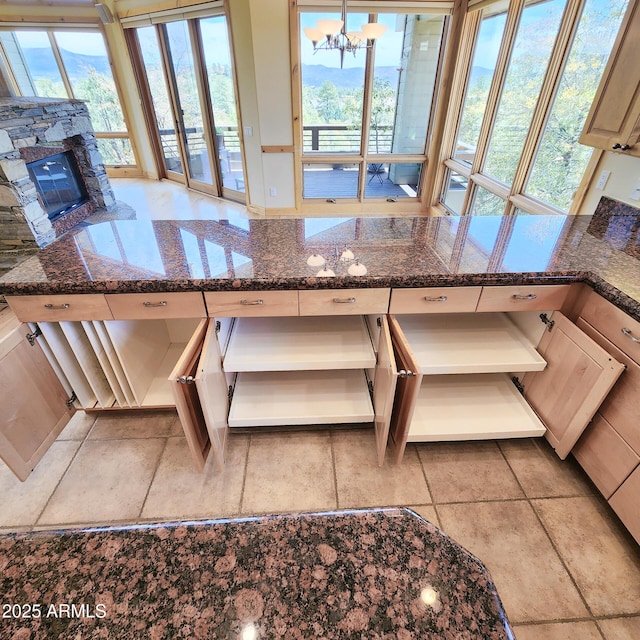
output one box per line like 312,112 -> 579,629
0,324 -> 73,481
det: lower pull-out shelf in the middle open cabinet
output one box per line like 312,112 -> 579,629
229,369 -> 374,427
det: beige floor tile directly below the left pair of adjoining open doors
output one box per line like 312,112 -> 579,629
142,435 -> 249,520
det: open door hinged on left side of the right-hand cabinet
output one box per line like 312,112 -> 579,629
389,315 -> 422,463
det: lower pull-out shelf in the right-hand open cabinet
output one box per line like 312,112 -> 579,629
408,373 -> 546,442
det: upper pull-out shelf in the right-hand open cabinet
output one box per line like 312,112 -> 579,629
396,313 -> 547,375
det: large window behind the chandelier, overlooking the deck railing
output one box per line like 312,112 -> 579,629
299,2 -> 446,202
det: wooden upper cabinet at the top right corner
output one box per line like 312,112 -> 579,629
580,0 -> 640,156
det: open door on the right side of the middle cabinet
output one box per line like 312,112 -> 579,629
373,316 -> 398,466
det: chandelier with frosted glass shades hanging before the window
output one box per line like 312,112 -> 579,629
304,0 -> 387,69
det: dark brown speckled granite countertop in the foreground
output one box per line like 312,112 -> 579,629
0,508 -> 513,640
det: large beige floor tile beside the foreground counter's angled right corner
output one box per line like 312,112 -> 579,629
438,500 -> 588,624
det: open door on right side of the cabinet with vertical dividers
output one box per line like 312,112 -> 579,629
169,319 -> 211,471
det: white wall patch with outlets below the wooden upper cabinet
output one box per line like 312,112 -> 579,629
579,151 -> 640,214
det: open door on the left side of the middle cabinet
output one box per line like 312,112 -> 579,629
196,320 -> 229,468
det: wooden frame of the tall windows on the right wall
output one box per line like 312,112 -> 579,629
432,0 -> 601,215
